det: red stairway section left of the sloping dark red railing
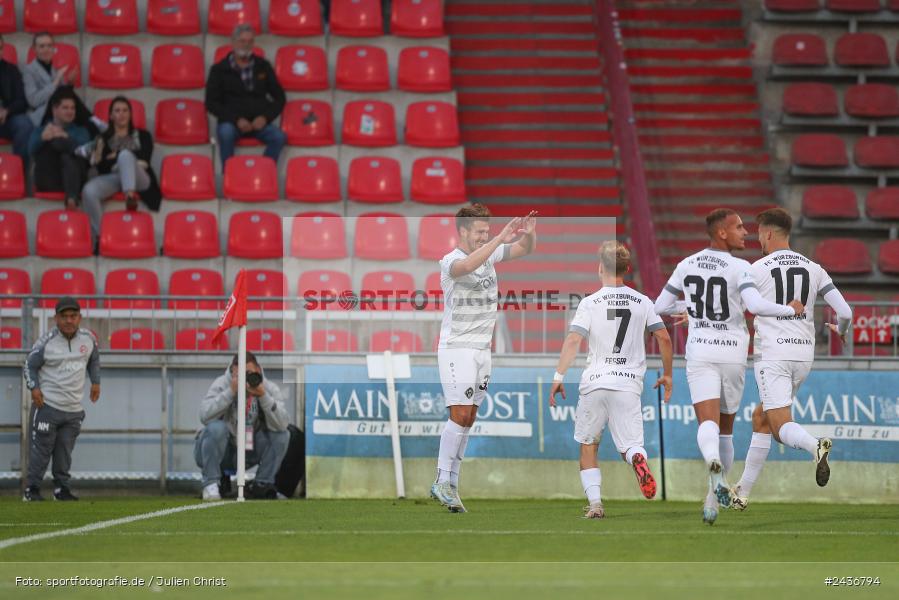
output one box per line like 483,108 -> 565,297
445,0 -> 622,352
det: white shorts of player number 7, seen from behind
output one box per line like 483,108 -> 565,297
574,389 -> 643,452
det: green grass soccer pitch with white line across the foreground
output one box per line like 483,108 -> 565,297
0,497 -> 899,600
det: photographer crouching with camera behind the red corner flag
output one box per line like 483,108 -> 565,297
194,352 -> 290,501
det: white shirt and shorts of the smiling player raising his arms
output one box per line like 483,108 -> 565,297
437,244 -> 511,406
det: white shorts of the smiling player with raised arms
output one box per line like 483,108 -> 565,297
437,348 -> 491,406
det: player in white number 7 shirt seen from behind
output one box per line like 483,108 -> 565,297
549,241 -> 672,519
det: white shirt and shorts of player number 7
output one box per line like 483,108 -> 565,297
570,286 -> 665,452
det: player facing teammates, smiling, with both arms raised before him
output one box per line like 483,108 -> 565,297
431,204 -> 537,512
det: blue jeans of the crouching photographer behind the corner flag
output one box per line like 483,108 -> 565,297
194,421 -> 290,487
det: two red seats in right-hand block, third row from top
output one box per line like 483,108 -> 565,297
783,82 -> 899,119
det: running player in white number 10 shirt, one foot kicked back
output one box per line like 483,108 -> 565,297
734,208 -> 852,509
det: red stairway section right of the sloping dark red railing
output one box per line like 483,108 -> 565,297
617,0 -> 774,272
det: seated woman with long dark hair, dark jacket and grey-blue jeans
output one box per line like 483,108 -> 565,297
81,96 -> 162,239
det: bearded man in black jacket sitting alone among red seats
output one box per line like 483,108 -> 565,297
206,23 -> 287,167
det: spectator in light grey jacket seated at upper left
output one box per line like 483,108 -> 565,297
22,31 -> 106,138
